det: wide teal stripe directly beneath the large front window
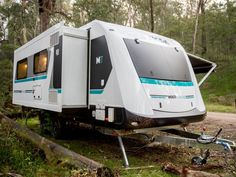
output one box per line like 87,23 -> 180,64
139,77 -> 193,87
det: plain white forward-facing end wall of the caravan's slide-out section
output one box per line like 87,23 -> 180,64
62,35 -> 87,106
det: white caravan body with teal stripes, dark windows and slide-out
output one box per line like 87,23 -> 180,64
13,20 -> 214,129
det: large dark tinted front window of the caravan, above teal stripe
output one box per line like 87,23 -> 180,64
124,39 -> 191,81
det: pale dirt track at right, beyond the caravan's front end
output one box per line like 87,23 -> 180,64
188,112 -> 236,141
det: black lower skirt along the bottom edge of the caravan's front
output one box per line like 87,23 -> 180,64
60,105 -> 206,130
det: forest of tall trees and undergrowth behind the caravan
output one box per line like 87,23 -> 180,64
0,0 -> 236,115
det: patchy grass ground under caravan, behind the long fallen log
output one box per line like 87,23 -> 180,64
19,119 -> 236,177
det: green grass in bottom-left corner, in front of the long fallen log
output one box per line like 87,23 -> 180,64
0,122 -> 93,177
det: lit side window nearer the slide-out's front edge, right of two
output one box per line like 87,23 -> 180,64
34,50 -> 48,74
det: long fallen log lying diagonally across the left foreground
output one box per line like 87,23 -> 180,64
0,112 -> 114,176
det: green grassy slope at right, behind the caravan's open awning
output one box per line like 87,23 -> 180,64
200,57 -> 236,110
